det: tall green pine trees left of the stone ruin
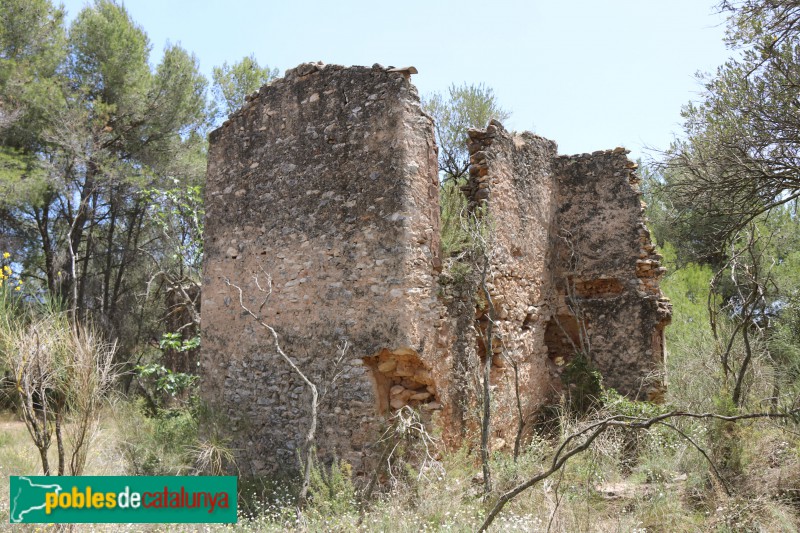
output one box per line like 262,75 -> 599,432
0,0 -> 209,366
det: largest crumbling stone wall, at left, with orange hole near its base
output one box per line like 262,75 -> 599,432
202,64 -> 447,473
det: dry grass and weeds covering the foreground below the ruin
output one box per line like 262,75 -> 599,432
0,400 -> 800,532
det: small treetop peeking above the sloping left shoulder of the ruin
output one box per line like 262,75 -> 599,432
211,54 -> 278,120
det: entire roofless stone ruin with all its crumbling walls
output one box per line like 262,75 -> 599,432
201,63 -> 670,474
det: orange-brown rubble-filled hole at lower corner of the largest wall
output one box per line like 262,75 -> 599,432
364,348 -> 442,414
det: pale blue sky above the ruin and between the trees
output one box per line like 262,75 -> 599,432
59,0 -> 730,157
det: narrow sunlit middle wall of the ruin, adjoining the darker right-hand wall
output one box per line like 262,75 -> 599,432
464,121 -> 556,449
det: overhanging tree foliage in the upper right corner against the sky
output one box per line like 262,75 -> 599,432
667,0 -> 800,244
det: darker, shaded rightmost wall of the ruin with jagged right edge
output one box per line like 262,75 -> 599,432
551,152 -> 671,399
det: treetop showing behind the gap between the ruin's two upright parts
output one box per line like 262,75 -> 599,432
423,84 -> 511,181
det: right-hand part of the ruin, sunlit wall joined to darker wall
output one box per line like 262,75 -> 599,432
456,122 -> 670,448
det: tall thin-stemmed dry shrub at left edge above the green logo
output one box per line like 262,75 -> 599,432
0,292 -> 116,475
